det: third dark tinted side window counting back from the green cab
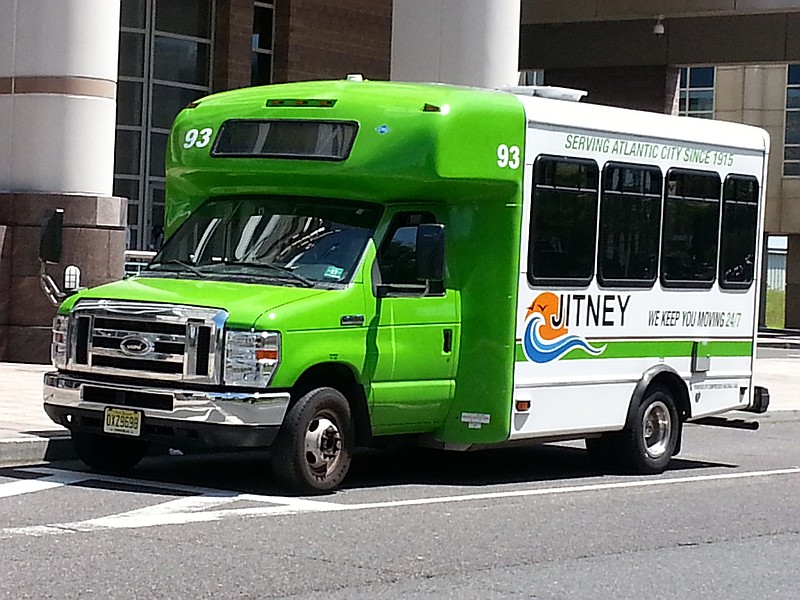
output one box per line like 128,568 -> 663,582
661,169 -> 721,288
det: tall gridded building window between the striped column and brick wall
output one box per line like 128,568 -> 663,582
114,0 -> 215,250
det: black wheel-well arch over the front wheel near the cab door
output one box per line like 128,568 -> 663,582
289,363 -> 372,445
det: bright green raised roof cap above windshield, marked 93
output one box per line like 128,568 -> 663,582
166,80 -> 525,231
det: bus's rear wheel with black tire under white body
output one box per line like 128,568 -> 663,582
618,386 -> 682,475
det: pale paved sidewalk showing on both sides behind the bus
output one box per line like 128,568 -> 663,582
0,330 -> 800,467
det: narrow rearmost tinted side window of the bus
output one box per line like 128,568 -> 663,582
719,175 -> 758,288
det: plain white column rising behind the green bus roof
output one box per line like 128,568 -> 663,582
391,0 -> 520,88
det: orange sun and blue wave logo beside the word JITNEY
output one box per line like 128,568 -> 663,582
522,292 -> 606,363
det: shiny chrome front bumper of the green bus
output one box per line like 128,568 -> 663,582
44,372 -> 290,447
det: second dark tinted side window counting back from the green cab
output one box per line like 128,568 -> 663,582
597,164 -> 662,285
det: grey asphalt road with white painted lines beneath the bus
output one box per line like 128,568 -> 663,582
0,413 -> 800,600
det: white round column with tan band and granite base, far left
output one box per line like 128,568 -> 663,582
0,0 -> 125,361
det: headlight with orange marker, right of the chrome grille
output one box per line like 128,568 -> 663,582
224,331 -> 281,387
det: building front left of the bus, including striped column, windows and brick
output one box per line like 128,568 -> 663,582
0,0 -> 392,362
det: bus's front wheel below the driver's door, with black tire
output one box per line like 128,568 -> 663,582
271,388 -> 354,494
